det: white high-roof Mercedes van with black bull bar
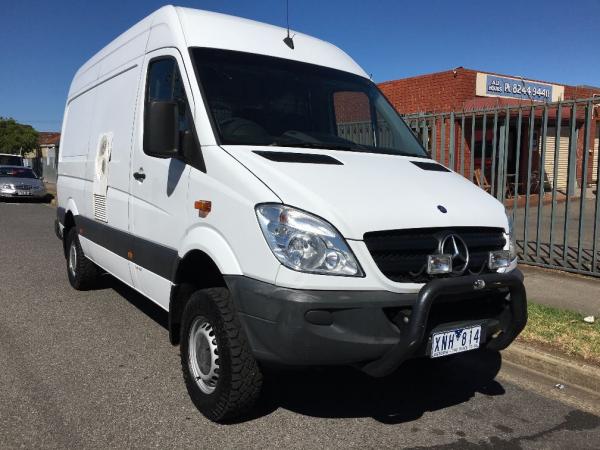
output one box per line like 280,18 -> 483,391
57,6 -> 526,421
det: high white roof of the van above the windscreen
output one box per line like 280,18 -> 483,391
69,5 -> 368,98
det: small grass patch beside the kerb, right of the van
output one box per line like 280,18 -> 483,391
518,303 -> 600,365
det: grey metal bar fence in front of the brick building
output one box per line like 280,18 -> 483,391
404,98 -> 600,277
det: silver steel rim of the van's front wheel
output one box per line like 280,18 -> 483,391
188,317 -> 219,394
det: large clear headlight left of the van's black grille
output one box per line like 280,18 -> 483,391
256,204 -> 363,277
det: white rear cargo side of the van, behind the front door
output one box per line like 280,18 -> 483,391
58,20 -> 151,285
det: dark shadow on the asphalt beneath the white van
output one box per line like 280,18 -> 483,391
89,274 -> 505,424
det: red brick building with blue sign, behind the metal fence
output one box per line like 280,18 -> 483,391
379,67 -> 600,190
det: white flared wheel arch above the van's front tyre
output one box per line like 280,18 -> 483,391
179,226 -> 242,275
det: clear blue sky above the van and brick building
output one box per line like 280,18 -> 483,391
0,0 -> 600,131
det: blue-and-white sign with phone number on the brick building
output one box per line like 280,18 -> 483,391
476,73 -> 565,102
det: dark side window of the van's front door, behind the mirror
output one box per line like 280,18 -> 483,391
144,57 -> 205,171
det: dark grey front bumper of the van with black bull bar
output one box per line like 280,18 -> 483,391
226,270 -> 527,376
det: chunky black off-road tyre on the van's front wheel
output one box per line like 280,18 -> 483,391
180,288 -> 263,422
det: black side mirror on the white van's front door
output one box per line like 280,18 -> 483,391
144,101 -> 179,158
